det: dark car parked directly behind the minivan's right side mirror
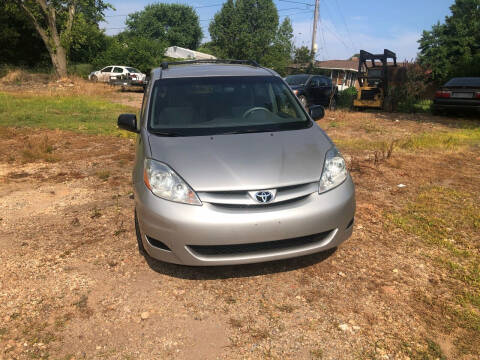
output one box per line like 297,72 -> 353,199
285,74 -> 338,110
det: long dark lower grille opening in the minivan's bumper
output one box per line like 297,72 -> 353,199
187,230 -> 333,256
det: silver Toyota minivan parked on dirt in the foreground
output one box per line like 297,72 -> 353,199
118,60 -> 355,265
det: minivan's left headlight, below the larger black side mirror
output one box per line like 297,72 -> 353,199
143,159 -> 202,205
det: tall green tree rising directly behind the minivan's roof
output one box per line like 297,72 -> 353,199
209,0 -> 278,61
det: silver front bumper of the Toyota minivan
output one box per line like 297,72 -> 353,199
134,176 -> 355,266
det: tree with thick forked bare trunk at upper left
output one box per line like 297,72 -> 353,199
9,0 -> 110,77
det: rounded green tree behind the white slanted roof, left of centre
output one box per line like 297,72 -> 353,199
126,3 -> 203,50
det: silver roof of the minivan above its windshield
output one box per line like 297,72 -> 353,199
152,63 -> 279,80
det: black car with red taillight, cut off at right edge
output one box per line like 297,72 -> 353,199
432,77 -> 480,114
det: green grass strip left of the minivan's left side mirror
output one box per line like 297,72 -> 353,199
0,93 -> 137,137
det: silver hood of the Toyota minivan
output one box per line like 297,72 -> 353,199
149,124 -> 333,191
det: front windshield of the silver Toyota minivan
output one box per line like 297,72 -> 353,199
148,76 -> 311,136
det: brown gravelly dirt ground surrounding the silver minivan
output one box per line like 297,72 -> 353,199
0,111 -> 480,359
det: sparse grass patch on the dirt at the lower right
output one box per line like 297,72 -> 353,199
387,186 -> 480,358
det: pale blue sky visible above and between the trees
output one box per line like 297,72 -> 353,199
101,0 -> 454,60
